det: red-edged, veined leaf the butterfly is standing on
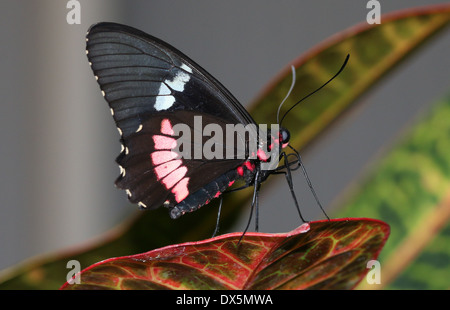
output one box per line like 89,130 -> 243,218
61,219 -> 389,290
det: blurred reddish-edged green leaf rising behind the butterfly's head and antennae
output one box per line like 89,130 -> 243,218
252,5 -> 450,149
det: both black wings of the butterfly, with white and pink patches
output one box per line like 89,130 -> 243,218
86,23 -> 255,217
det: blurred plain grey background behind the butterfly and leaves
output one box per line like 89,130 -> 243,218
0,0 -> 450,269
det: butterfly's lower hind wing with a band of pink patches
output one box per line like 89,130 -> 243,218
116,111 -> 245,214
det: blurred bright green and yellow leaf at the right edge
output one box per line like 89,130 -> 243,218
338,96 -> 450,289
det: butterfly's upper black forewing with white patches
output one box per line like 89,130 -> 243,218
86,23 -> 254,137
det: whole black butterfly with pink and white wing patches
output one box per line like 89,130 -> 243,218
86,22 -> 340,232
